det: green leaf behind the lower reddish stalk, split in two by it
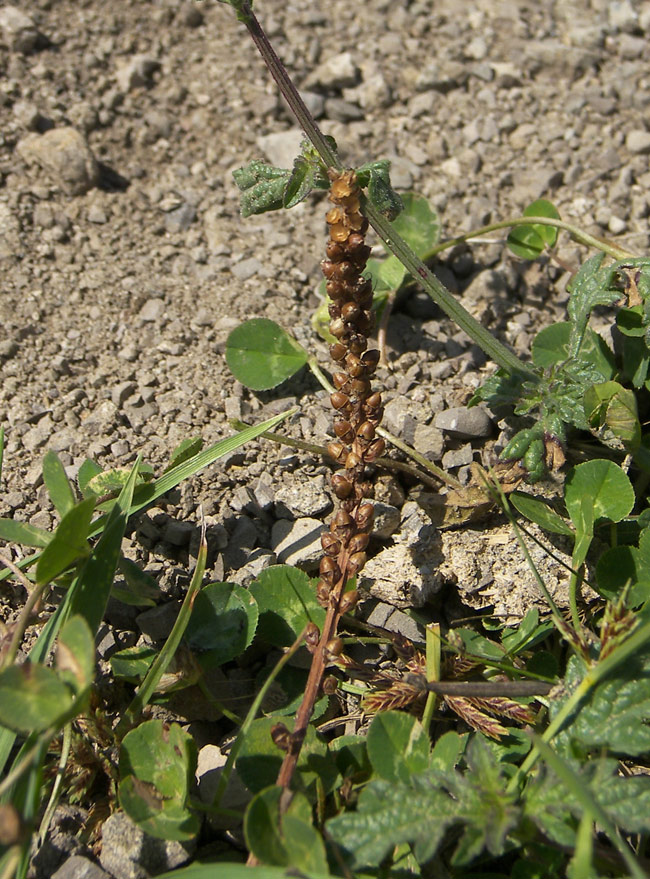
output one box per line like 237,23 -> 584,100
236,716 -> 338,794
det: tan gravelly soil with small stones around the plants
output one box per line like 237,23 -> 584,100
0,0 -> 650,879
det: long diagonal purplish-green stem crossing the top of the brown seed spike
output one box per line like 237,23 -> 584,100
235,2 -> 537,381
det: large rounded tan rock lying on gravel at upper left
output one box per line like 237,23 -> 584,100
16,126 -> 99,195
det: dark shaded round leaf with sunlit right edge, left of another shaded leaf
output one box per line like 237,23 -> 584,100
185,583 -> 258,669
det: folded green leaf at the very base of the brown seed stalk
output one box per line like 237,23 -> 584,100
244,786 -> 327,873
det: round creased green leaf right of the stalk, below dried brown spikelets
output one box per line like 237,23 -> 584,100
367,711 -> 430,781
